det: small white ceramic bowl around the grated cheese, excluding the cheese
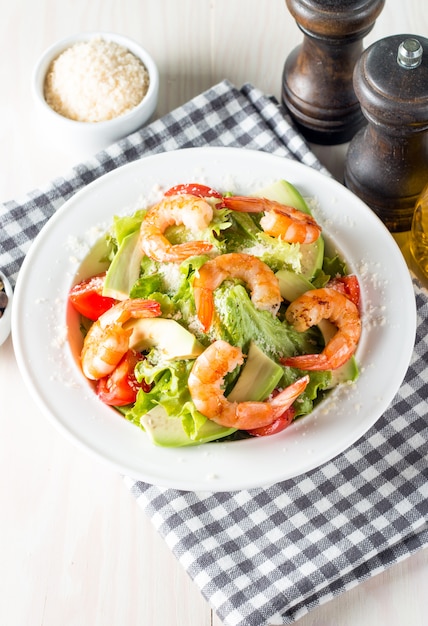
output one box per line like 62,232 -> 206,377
32,32 -> 159,156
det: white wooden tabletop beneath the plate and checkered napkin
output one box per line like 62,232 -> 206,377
0,0 -> 428,626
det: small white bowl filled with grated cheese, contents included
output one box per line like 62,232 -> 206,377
33,32 -> 159,156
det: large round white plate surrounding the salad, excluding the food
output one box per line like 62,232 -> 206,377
12,148 -> 416,491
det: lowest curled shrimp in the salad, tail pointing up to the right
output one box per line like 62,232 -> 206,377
188,339 -> 309,430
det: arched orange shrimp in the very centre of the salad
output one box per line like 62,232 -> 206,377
193,252 -> 282,331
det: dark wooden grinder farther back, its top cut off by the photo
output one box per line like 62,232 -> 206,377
282,0 -> 385,145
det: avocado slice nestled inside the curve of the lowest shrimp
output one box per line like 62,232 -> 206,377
227,341 -> 284,402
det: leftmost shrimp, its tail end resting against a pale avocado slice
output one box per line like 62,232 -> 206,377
81,298 -> 161,380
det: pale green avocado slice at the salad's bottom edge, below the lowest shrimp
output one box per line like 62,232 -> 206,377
141,405 -> 236,448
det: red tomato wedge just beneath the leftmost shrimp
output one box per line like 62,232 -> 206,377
97,350 -> 150,406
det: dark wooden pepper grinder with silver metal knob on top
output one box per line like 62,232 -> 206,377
344,35 -> 428,233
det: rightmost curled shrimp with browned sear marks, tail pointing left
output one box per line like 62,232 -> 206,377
281,287 -> 361,370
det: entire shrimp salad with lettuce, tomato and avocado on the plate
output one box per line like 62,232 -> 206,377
69,180 -> 361,447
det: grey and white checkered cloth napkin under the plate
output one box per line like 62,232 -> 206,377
0,81 -> 428,626
